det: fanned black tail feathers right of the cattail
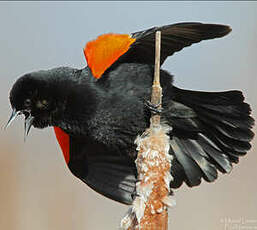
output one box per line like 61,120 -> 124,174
165,87 -> 254,188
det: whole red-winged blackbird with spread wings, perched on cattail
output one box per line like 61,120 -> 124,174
8,23 -> 254,204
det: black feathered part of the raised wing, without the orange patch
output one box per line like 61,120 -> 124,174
125,22 -> 231,64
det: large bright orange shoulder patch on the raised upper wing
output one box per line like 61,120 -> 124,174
84,34 -> 136,78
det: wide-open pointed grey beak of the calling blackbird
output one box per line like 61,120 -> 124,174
4,109 -> 34,141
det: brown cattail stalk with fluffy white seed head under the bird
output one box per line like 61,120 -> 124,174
121,31 -> 174,230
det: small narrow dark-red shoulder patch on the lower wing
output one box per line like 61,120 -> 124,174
54,126 -> 70,164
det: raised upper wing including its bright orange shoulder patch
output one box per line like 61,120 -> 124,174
84,22 -> 231,78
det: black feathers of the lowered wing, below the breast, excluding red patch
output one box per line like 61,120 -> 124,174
68,137 -> 136,204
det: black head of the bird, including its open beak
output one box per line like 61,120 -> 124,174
6,68 -> 84,136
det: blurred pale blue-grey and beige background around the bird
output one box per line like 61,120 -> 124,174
0,1 -> 257,230
